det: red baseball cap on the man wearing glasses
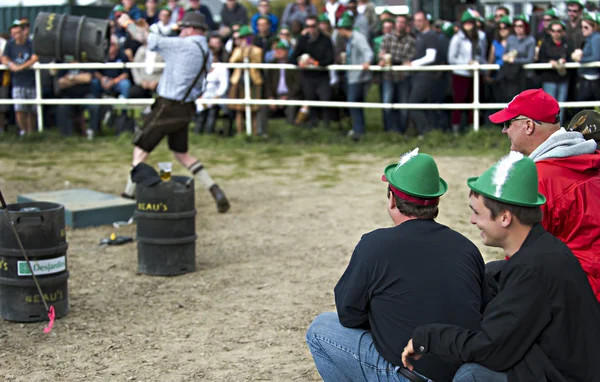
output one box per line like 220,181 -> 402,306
490,89 -> 560,124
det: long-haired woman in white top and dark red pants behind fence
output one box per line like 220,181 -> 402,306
448,9 -> 486,134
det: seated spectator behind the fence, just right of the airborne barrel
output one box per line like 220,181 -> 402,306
92,35 -> 131,98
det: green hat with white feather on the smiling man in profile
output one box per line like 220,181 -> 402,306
467,151 -> 546,207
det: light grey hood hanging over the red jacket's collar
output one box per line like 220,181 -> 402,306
529,127 -> 597,162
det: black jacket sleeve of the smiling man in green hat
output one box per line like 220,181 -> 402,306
412,266 -> 551,371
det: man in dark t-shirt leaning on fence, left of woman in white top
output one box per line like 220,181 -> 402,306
406,12 -> 438,137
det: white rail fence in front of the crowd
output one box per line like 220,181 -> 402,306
0,62 -> 600,135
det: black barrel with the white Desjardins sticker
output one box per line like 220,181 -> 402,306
0,202 -> 69,322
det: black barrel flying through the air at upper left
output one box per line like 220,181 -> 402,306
33,12 -> 110,62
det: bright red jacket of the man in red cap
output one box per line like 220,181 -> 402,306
536,151 -> 600,301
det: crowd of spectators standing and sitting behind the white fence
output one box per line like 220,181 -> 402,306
0,0 -> 600,140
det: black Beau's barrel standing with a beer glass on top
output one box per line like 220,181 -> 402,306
135,176 -> 197,276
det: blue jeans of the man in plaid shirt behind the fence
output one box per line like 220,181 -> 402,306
381,79 -> 410,133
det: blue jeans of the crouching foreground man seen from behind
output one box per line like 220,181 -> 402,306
306,312 -> 432,382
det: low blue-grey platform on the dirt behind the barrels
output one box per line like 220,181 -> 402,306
17,188 -> 135,228
